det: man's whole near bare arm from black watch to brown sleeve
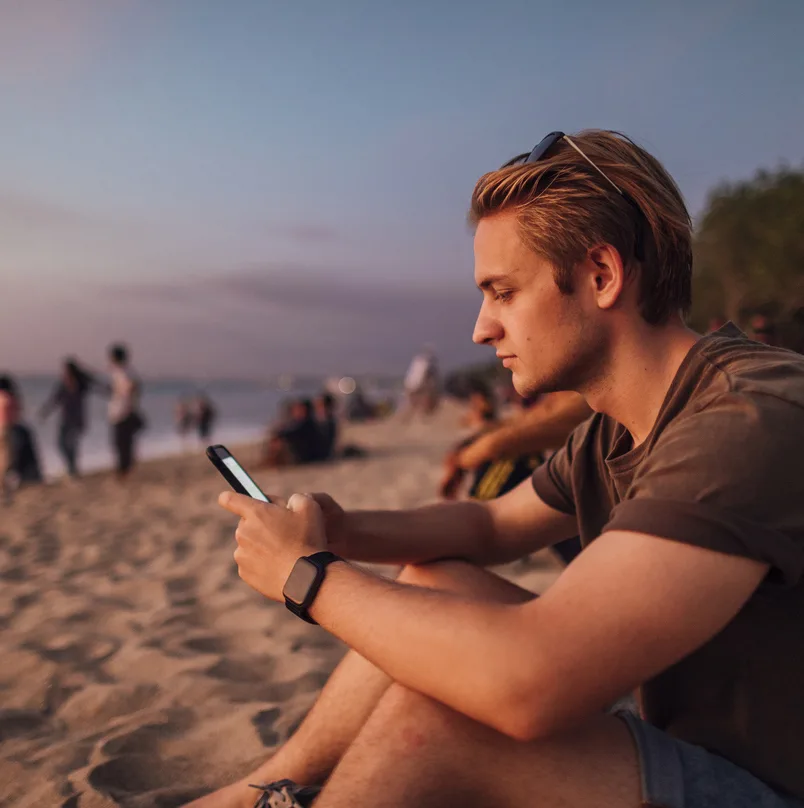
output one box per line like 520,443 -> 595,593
311,532 -> 768,740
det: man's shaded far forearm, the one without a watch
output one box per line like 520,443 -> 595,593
333,502 -> 494,564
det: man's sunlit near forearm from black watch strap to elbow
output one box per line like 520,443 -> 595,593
310,564 -> 538,735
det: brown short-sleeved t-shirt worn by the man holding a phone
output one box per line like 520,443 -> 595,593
533,323 -> 804,798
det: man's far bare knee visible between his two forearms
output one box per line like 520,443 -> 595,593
397,559 -> 535,604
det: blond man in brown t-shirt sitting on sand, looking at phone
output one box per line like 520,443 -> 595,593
190,131 -> 804,808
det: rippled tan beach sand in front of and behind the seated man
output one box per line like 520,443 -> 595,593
0,404 -> 560,808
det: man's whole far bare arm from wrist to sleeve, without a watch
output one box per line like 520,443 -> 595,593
332,480 -> 578,565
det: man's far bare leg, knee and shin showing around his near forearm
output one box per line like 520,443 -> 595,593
187,561 -> 534,808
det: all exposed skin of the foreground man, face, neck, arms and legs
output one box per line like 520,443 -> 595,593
187,214 -> 768,808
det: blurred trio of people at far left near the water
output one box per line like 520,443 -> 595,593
0,343 -> 145,499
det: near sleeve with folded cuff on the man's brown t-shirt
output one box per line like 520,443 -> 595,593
605,393 -> 804,586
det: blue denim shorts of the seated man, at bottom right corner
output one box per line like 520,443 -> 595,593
615,710 -> 804,808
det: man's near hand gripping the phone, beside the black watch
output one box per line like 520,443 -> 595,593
218,491 -> 326,602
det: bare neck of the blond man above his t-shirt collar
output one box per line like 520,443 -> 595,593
582,320 -> 700,446
